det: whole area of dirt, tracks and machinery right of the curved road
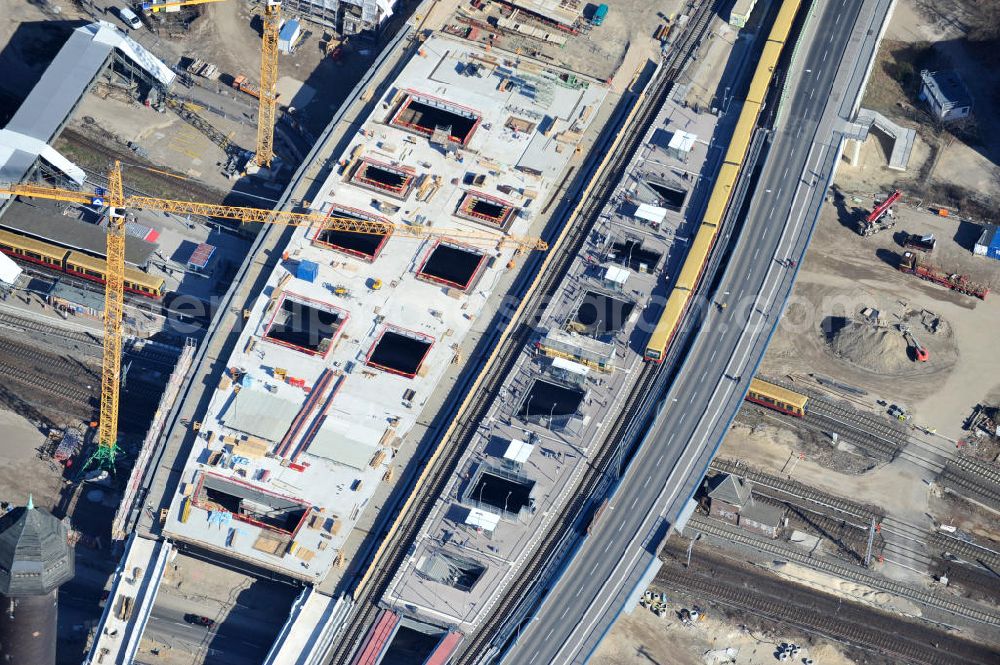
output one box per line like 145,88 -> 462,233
592,2 -> 1000,663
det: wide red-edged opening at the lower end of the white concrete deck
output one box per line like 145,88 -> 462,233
192,474 -> 311,534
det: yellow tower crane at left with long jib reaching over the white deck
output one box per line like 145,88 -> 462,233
0,161 -> 548,472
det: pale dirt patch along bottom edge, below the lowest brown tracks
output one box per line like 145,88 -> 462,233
590,596 -> 855,665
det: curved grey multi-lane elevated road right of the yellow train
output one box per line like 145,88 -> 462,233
504,0 -> 887,665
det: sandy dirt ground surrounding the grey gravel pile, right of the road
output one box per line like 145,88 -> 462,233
761,189 -> 1000,439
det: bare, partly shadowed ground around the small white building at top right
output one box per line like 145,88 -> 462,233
837,0 -> 1000,213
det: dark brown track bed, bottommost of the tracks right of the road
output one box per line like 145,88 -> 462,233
656,557 -> 996,665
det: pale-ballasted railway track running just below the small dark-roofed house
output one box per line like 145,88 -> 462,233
688,516 -> 1000,626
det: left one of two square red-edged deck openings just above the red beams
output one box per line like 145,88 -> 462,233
264,293 -> 347,357
